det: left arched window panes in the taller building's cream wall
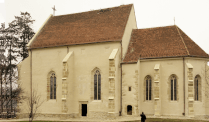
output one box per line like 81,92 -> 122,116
50,73 -> 56,99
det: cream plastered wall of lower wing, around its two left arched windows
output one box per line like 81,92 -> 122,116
122,59 -> 183,116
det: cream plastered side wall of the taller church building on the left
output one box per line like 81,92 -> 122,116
19,42 -> 121,117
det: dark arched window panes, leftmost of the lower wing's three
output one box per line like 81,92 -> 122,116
145,76 -> 152,100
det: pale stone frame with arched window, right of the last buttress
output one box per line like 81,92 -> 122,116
194,75 -> 202,102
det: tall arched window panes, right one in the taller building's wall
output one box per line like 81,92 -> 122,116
94,70 -> 101,100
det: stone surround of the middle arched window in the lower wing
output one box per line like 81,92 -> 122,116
167,74 -> 179,102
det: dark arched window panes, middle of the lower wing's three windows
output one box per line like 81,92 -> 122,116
170,75 -> 177,101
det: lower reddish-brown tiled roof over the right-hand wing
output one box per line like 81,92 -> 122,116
123,25 -> 209,62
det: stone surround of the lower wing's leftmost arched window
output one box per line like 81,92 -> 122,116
144,75 -> 154,102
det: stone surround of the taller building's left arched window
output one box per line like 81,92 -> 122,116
47,71 -> 58,101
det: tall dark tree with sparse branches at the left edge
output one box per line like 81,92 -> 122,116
0,12 -> 35,118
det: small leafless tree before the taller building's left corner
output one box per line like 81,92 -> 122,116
26,89 -> 44,122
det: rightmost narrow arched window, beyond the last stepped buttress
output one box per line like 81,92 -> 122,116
194,75 -> 201,101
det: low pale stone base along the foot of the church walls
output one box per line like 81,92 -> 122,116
13,111 -> 209,121
